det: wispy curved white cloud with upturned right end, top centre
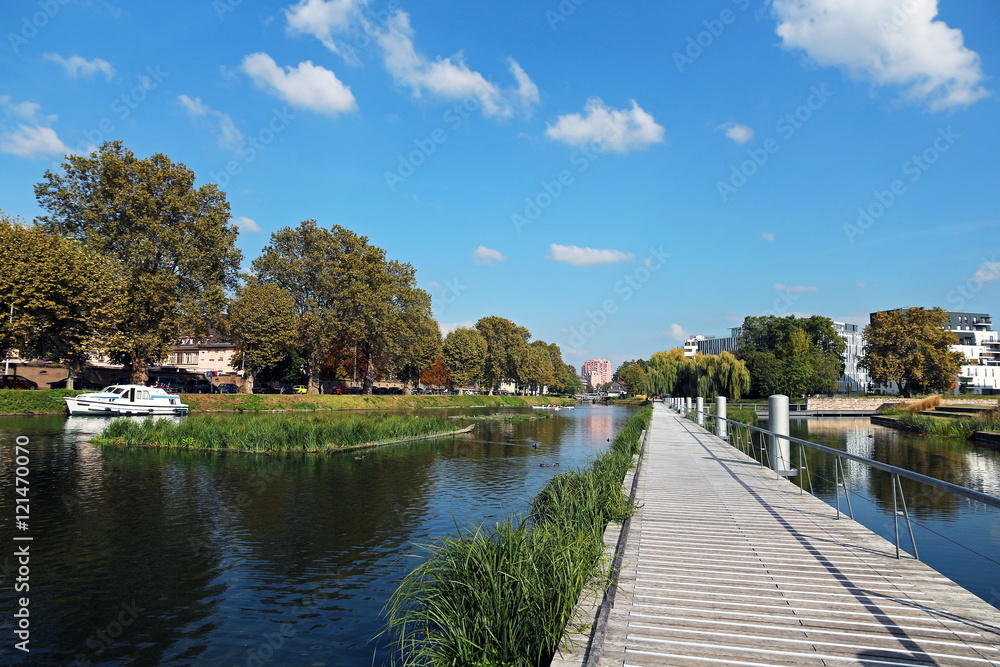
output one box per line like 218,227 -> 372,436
376,11 -> 539,118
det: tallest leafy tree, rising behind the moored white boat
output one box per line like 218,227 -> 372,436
35,141 -> 242,384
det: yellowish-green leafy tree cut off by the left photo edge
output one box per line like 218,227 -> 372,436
0,213 -> 122,389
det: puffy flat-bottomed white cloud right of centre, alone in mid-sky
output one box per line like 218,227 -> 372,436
545,97 -> 663,153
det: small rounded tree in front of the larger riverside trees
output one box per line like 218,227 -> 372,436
224,278 -> 295,394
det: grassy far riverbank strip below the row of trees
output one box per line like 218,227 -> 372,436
0,389 -> 576,415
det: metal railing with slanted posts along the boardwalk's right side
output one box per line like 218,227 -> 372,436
671,406 -> 1000,560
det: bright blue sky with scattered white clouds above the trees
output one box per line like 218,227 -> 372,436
0,0 -> 1000,366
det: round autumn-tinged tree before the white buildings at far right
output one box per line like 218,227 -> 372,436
858,308 -> 965,396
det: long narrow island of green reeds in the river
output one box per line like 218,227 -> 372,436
94,414 -> 459,452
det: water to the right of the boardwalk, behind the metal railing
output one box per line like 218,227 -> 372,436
732,418 -> 1000,608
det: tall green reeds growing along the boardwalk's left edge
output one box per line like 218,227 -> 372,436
384,408 -> 652,667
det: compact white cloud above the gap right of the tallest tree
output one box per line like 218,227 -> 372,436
240,53 -> 357,116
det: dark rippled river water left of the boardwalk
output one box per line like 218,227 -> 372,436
0,406 -> 634,667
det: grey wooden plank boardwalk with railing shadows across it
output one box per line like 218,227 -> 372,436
553,404 -> 1000,667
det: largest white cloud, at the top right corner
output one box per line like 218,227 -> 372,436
773,0 -> 987,110
